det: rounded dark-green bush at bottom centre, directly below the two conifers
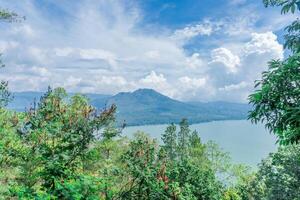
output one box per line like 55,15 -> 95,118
166,159 -> 223,200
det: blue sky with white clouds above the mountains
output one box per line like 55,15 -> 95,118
0,0 -> 296,102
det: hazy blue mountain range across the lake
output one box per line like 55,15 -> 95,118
9,89 -> 250,125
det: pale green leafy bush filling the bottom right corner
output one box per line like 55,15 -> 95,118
240,145 -> 300,200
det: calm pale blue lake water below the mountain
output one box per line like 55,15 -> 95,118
123,120 -> 276,167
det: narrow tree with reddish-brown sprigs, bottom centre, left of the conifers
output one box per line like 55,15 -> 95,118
119,132 -> 167,200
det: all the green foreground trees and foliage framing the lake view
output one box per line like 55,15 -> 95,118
0,0 -> 300,200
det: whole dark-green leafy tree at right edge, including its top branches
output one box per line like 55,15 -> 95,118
249,0 -> 300,145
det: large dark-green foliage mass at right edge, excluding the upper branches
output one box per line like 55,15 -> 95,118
249,54 -> 300,144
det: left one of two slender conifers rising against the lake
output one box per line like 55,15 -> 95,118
162,124 -> 177,160
